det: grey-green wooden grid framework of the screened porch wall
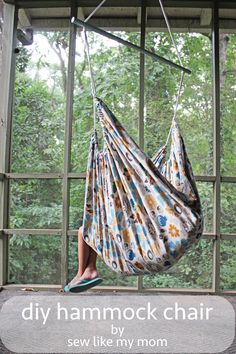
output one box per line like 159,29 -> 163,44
0,2 -> 236,294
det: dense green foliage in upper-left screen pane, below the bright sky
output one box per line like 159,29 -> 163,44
12,72 -> 65,172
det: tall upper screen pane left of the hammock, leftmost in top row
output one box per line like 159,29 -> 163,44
11,22 -> 69,172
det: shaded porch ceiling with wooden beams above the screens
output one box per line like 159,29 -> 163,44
5,0 -> 236,33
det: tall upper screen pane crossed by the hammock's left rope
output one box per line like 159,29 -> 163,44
71,32 -> 140,172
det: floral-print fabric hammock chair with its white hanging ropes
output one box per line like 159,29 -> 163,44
74,3 -> 203,275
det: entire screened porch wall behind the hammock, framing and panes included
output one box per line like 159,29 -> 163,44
0,2 -> 236,292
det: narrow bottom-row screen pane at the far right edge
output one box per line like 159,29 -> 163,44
220,239 -> 236,290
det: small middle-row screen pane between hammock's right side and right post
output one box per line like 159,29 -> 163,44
197,182 -> 213,232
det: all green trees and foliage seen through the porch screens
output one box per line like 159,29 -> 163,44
9,32 -> 236,289
